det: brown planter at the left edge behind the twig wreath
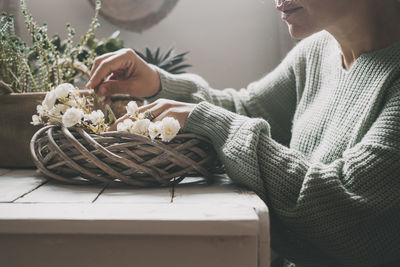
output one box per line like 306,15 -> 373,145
0,92 -> 46,168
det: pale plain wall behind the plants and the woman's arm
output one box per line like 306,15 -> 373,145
19,0 -> 290,88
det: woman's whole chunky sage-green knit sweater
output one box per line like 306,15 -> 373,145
147,32 -> 400,266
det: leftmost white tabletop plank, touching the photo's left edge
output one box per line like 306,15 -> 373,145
0,170 -> 47,202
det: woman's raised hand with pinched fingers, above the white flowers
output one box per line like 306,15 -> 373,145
86,49 -> 161,102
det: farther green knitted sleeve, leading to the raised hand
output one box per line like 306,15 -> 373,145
148,46 -> 300,145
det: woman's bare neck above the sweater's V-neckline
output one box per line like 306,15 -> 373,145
327,0 -> 400,69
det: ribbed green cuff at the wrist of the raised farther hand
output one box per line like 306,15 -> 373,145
146,65 -> 197,103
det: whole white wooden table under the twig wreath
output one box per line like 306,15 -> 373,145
0,169 -> 270,267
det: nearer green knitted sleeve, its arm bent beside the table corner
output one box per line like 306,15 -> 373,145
185,86 -> 400,266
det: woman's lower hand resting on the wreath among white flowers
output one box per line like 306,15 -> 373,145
108,99 -> 196,131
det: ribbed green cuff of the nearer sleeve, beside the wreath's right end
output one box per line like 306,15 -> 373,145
183,101 -> 250,147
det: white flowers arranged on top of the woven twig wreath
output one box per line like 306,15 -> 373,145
31,89 -> 180,142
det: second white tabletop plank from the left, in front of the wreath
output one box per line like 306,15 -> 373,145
15,181 -> 104,203
